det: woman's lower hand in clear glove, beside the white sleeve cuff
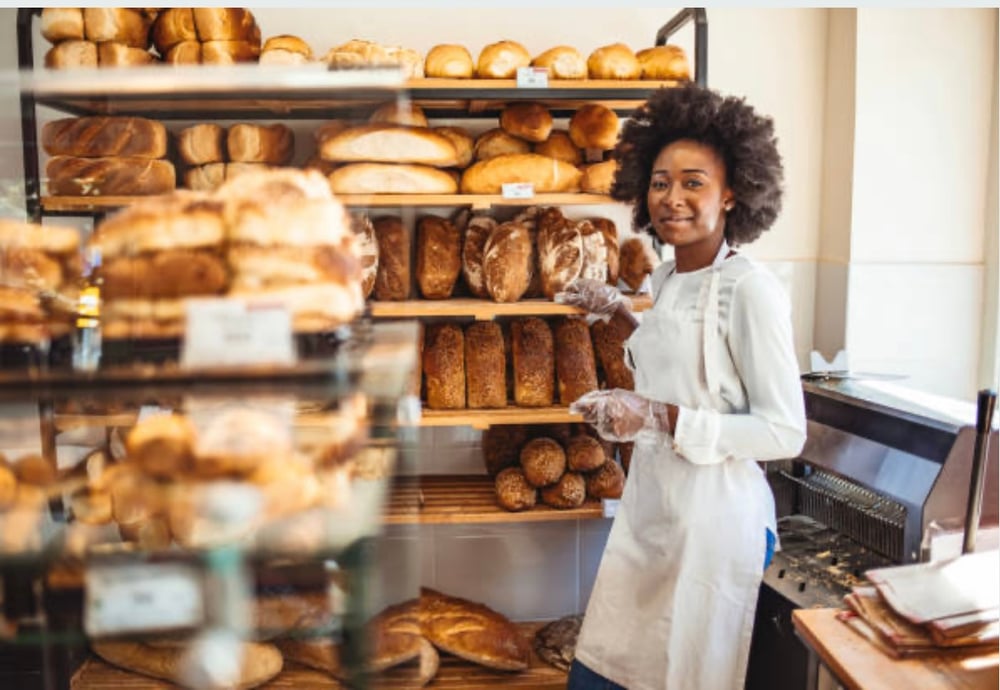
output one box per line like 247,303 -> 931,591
569,388 -> 670,443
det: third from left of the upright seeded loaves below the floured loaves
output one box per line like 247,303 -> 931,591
510,317 -> 555,407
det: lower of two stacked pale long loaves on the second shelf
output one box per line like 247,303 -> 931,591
329,162 -> 458,194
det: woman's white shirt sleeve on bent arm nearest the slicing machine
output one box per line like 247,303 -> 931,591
673,271 -> 806,465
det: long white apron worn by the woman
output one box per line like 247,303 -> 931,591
576,243 -> 804,690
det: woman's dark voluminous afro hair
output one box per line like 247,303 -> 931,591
611,84 -> 783,245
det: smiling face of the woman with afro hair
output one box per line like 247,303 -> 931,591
646,139 -> 733,251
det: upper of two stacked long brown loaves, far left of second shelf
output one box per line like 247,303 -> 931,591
42,116 -> 167,158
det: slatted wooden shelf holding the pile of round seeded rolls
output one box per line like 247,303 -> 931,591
382,474 -> 604,525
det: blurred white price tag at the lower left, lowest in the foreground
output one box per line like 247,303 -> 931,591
83,563 -> 205,636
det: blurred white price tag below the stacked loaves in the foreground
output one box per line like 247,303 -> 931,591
181,298 -> 295,367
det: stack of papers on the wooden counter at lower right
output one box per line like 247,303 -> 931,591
838,551 -> 1000,658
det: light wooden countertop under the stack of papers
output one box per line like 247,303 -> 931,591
792,609 -> 1000,690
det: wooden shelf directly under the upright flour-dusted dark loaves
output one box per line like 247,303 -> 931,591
369,294 -> 653,321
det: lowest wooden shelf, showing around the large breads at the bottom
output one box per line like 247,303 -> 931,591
70,623 -> 566,690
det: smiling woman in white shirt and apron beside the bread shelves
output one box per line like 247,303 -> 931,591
558,85 -> 805,690
